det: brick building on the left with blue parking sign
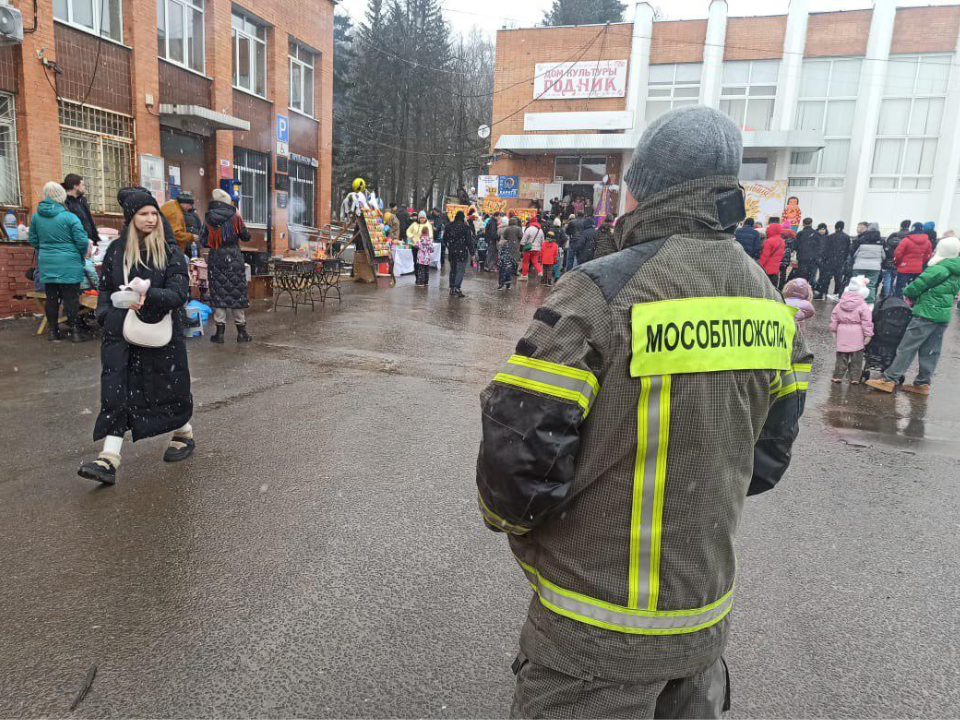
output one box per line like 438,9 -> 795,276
0,0 -> 335,317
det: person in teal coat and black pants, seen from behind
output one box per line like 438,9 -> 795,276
30,182 -> 89,342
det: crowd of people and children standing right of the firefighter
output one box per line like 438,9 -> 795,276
734,211 -> 960,395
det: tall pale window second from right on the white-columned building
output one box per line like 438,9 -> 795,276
790,58 -> 863,188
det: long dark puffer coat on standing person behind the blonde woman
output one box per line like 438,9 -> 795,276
201,200 -> 250,310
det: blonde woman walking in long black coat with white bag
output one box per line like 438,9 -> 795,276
77,189 -> 195,485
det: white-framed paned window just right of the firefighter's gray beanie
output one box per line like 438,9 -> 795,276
720,60 -> 780,130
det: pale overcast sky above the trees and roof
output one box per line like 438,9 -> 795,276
338,0 -> 957,35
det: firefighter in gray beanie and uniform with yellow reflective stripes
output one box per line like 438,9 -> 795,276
477,106 -> 811,720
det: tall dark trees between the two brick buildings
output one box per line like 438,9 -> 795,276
333,0 -> 494,213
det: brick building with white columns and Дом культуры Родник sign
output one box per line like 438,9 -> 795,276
490,0 -> 960,229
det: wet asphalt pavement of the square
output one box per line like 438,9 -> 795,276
0,268 -> 960,720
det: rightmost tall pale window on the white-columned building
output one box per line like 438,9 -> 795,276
870,55 -> 952,190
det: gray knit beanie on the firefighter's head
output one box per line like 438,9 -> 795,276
624,105 -> 743,202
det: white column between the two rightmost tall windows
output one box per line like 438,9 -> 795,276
843,0 -> 897,227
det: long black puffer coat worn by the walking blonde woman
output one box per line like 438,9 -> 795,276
93,233 -> 193,442
